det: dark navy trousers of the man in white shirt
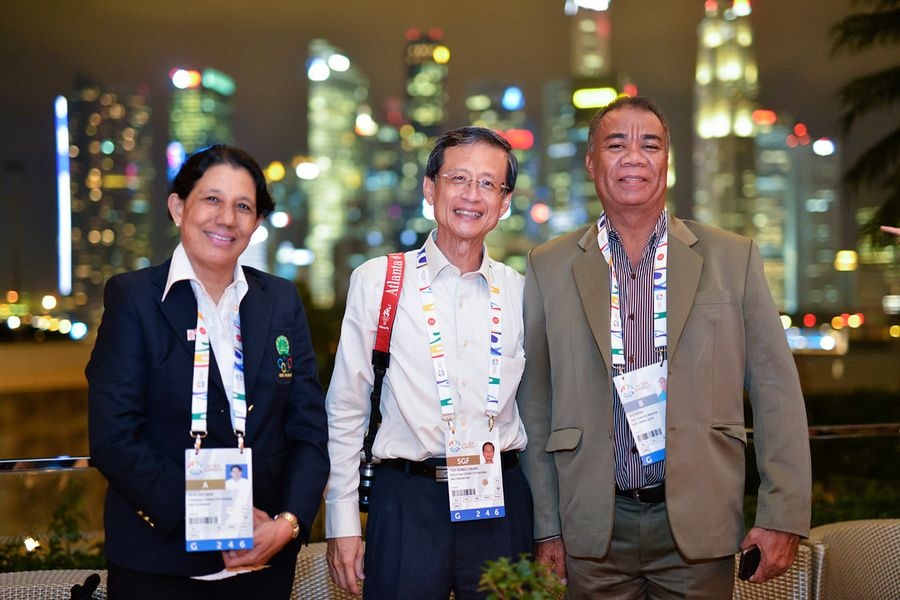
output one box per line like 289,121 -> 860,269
363,466 -> 533,600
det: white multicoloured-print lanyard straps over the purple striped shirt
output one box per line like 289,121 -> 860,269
597,211 -> 669,371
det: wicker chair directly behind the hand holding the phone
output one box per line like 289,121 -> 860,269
732,540 -> 825,600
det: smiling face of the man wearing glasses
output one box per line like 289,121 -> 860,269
422,142 -> 510,252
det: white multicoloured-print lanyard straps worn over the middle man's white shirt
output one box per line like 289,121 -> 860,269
416,246 -> 502,431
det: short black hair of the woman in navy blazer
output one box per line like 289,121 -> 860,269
169,144 -> 275,219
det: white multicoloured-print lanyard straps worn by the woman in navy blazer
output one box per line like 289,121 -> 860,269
191,302 -> 247,452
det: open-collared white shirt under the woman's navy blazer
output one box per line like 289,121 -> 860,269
162,243 -> 248,424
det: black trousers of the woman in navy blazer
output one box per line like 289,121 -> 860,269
106,558 -> 297,600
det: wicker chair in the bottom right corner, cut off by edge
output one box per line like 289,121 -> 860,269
809,519 -> 900,600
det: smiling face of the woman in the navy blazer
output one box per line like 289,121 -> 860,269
169,164 -> 262,285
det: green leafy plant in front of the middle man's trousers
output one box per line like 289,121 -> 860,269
478,554 -> 566,600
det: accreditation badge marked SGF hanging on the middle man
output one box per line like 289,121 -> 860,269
445,417 -> 506,521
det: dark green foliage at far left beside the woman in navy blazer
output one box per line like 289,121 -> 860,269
0,479 -> 106,572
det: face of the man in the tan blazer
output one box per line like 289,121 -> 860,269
585,107 -> 669,216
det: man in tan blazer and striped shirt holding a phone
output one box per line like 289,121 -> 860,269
518,97 -> 811,598
